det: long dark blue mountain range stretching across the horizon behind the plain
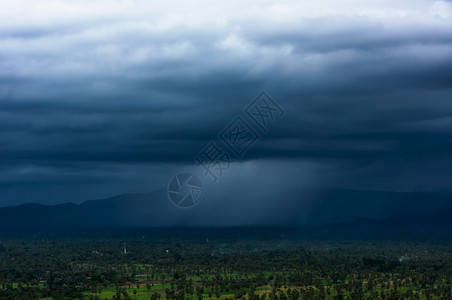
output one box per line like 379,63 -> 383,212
0,188 -> 452,237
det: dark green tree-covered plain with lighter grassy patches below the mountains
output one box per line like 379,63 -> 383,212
0,232 -> 452,300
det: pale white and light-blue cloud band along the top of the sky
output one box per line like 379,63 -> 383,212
0,0 -> 452,90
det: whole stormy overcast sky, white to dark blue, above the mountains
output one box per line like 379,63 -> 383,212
0,0 -> 452,206
